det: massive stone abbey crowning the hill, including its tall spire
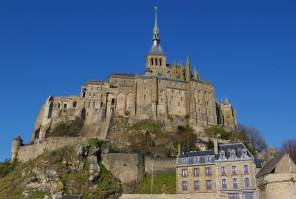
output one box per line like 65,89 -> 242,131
32,7 -> 236,141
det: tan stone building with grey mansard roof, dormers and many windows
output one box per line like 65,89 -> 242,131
176,142 -> 258,199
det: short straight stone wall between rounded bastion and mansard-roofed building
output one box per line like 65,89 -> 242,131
145,156 -> 176,174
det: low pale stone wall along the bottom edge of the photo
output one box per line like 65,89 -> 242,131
119,193 -> 219,199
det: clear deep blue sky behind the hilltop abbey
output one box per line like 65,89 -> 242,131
0,0 -> 296,161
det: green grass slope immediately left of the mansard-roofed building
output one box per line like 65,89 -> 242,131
135,172 -> 176,194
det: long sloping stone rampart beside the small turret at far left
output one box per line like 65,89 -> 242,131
17,137 -> 86,162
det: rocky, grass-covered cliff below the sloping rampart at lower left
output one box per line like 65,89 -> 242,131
0,139 -> 121,199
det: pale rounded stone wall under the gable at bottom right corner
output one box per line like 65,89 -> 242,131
258,173 -> 296,199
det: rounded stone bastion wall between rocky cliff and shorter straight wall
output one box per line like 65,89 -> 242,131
102,153 -> 144,184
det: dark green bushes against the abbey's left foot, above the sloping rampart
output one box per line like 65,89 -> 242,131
46,118 -> 83,137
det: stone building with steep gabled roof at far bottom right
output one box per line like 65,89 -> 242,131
257,154 -> 296,199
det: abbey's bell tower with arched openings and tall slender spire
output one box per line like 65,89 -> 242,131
145,7 -> 167,76
